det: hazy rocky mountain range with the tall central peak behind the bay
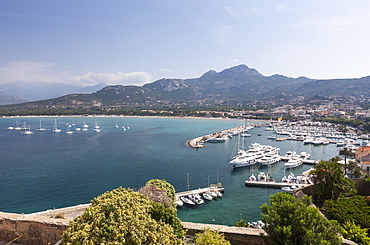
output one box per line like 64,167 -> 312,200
1,65 -> 370,108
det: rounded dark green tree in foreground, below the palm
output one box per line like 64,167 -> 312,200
261,192 -> 341,245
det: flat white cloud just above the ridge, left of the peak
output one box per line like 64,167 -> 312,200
74,71 -> 152,85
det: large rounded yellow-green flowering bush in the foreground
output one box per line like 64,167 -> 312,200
61,187 -> 181,245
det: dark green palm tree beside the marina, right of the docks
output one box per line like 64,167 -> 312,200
310,161 -> 357,202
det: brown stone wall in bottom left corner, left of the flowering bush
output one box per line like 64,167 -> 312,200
0,212 -> 69,245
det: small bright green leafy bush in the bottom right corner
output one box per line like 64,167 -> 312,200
341,221 -> 370,245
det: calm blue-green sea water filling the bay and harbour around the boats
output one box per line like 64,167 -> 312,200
0,117 -> 338,225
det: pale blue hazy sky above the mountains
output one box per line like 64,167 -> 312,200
0,0 -> 370,85
